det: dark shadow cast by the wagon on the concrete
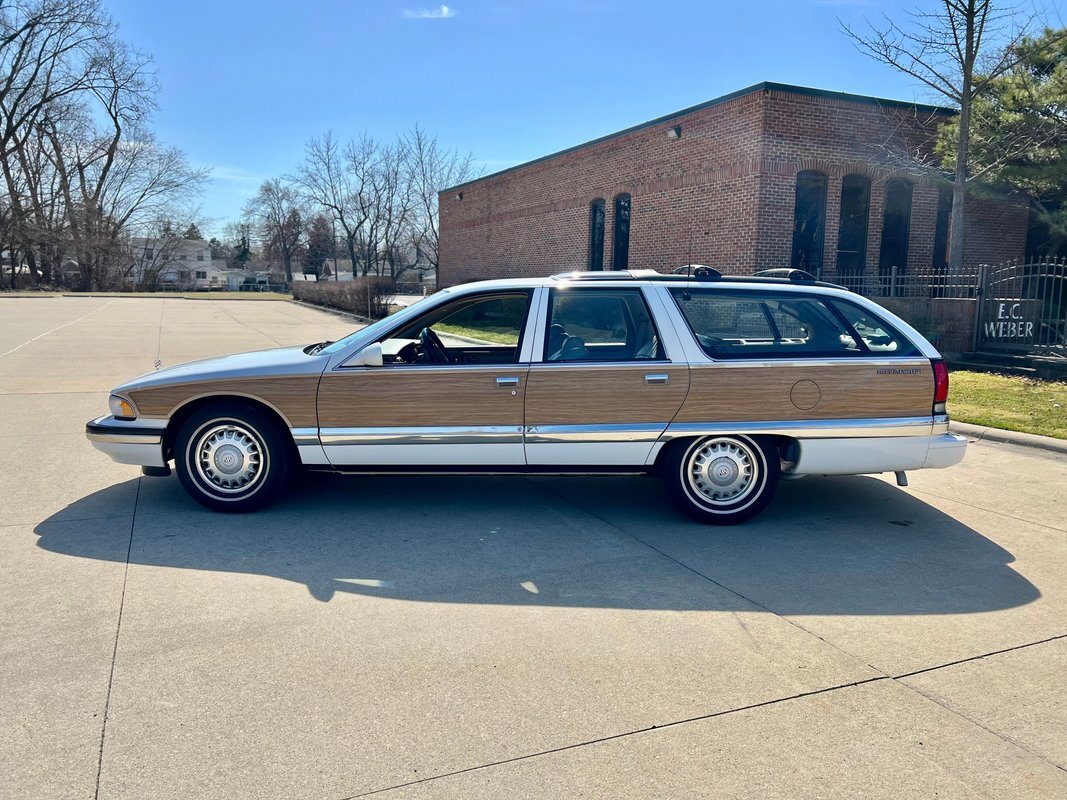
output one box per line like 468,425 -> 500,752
35,475 -> 1039,614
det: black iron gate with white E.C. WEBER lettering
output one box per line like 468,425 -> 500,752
975,258 -> 1067,357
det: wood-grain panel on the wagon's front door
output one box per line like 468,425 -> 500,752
319,366 -> 527,428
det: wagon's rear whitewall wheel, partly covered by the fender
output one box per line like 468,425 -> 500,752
663,435 -> 780,525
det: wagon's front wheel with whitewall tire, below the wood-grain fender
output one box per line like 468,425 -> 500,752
174,403 -> 290,512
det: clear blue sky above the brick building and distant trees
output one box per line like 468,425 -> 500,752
107,0 -> 1063,231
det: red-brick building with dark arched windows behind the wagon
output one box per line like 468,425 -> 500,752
440,83 -> 1026,286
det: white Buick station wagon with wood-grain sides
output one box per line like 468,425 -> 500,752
85,267 -> 966,524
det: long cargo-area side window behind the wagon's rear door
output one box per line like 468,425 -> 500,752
670,288 -> 867,358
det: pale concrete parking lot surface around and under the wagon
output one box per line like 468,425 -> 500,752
0,298 -> 1067,800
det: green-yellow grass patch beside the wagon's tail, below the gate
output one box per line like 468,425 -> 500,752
949,370 -> 1067,439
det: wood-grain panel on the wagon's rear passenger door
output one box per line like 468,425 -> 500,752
526,363 -> 689,426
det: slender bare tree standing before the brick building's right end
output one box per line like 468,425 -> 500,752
842,0 -> 1033,270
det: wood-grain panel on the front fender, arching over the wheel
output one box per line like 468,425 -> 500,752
130,374 -> 319,428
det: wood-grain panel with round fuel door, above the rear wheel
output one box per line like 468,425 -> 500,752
676,361 -> 934,422
